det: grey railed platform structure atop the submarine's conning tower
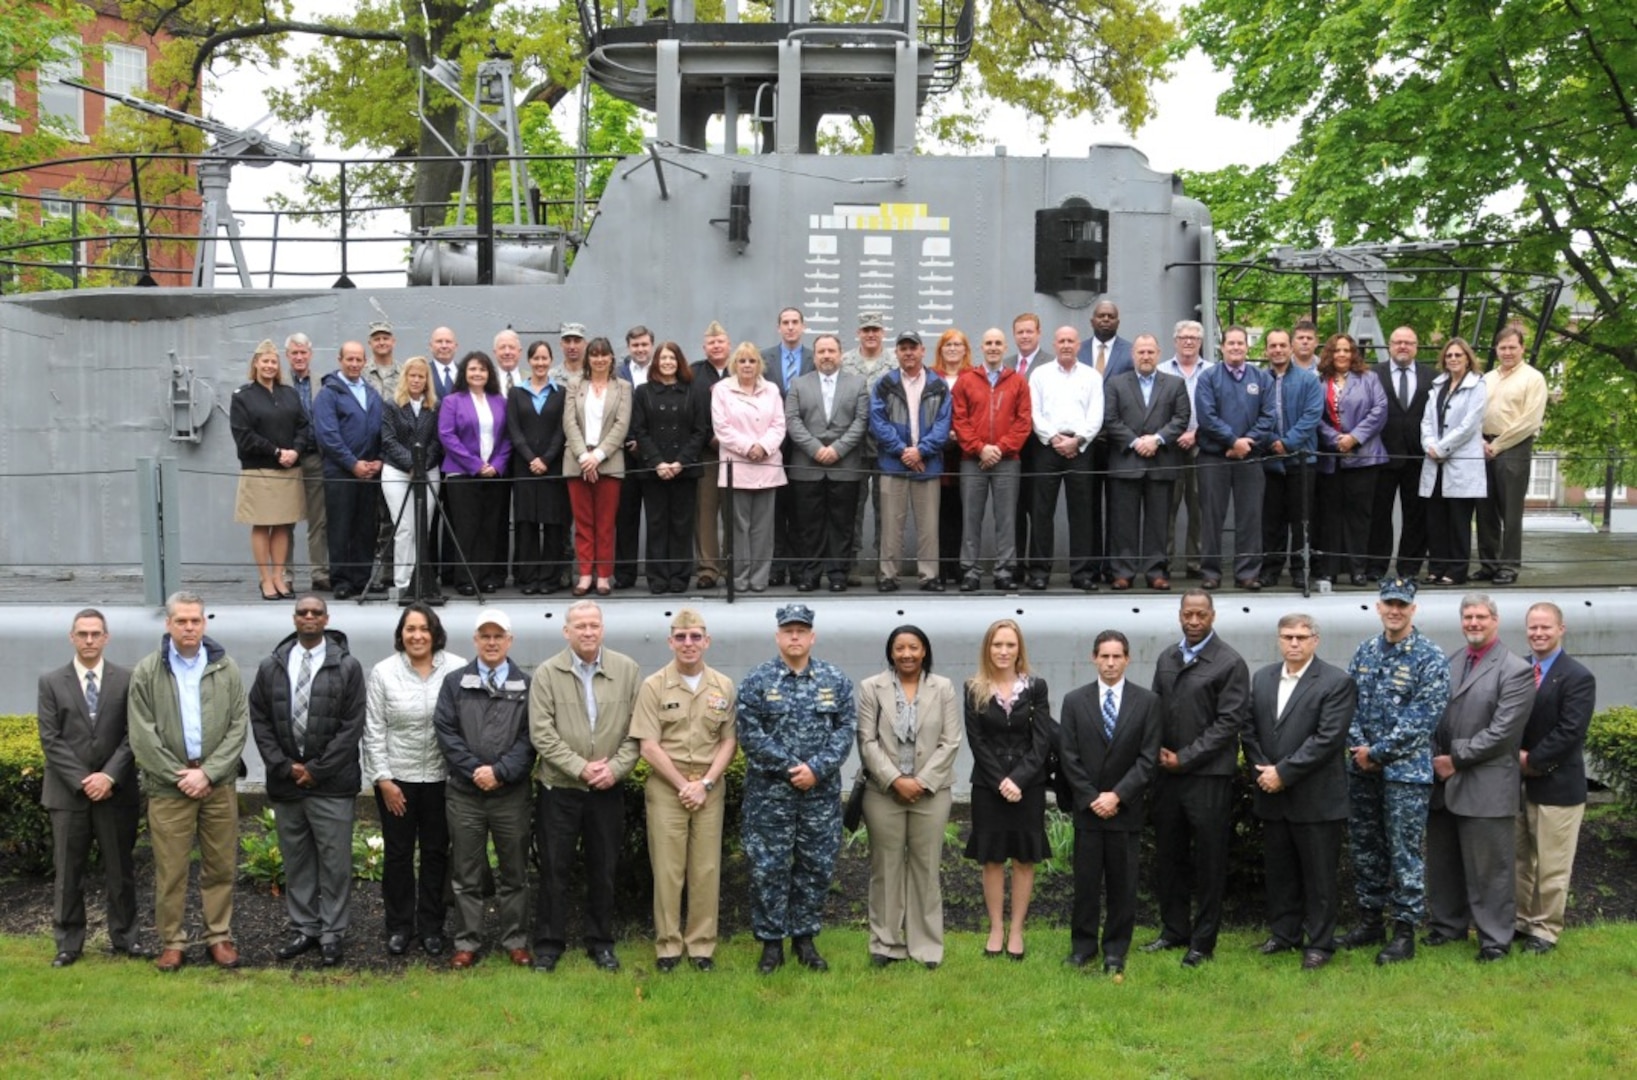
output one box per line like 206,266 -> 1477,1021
578,0 -> 972,154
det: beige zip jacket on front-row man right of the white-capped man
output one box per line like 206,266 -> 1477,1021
529,648 -> 642,790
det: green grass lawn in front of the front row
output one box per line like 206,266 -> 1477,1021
0,925 -> 1637,1080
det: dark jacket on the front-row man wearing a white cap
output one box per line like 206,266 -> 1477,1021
432,659 -> 534,795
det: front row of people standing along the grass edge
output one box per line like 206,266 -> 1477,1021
39,578 -> 1596,974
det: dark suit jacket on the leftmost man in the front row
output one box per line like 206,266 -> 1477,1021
36,659 -> 139,810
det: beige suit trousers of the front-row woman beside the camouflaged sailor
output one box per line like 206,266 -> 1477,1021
864,784 -> 949,964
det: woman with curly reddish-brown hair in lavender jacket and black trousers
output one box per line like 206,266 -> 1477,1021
1313,334 -> 1387,586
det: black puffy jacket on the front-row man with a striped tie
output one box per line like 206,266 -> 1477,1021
250,630 -> 368,802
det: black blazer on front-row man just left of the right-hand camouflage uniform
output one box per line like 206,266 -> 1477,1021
1241,656 -> 1359,821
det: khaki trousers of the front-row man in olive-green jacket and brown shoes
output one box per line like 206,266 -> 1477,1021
147,784 -> 239,949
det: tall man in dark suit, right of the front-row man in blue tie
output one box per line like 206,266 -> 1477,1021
1143,589 -> 1251,967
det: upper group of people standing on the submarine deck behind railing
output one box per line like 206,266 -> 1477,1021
231,307 -> 1547,604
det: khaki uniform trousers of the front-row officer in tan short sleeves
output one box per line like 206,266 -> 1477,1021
643,774 -> 727,957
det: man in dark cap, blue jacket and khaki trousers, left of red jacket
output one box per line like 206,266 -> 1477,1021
869,331 -> 954,592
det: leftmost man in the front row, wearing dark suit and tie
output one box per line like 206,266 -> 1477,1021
36,607 -> 152,967
